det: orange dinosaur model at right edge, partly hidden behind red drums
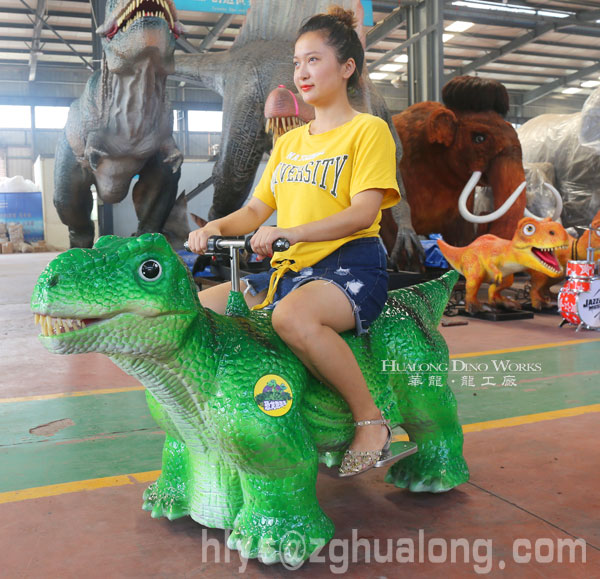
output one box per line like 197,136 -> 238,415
527,211 -> 600,310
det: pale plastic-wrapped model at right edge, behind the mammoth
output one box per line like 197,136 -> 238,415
517,89 -> 600,227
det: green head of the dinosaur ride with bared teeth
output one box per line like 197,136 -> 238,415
31,233 -> 200,359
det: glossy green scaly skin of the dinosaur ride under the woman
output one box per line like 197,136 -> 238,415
31,234 -> 468,563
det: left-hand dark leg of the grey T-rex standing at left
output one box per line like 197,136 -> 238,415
54,133 -> 95,247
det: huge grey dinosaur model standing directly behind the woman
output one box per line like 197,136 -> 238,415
175,0 -> 422,264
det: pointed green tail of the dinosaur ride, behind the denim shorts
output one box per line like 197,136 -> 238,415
388,270 -> 459,329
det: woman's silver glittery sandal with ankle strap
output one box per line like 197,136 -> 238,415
339,415 -> 417,477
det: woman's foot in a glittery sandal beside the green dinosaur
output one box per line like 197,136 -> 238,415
339,415 -> 392,477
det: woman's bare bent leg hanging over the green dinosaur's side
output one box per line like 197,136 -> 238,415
272,280 -> 388,451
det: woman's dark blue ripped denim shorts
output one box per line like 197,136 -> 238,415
242,237 -> 388,335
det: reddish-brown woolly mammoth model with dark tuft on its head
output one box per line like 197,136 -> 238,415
394,76 -> 525,245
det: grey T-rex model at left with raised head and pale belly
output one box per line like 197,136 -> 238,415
54,0 -> 183,247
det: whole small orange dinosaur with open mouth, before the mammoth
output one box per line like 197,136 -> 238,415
438,217 -> 568,313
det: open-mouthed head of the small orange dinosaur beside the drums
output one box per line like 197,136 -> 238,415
513,217 -> 569,277
